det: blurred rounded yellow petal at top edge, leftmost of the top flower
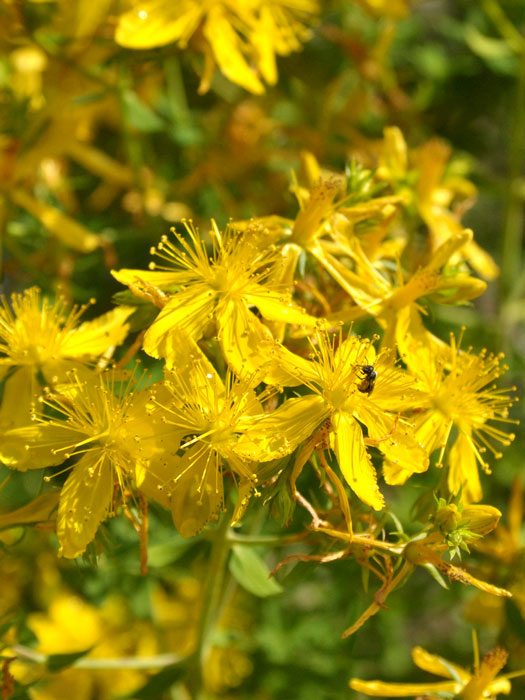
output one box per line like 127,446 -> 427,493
115,0 -> 203,49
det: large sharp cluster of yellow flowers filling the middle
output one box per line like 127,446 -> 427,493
0,137 -> 514,634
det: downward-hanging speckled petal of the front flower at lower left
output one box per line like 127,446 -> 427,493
57,454 -> 113,559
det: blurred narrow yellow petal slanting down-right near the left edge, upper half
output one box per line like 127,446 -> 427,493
10,189 -> 100,253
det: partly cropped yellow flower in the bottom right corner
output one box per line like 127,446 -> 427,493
350,647 -> 514,700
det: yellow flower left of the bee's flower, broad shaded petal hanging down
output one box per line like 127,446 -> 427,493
141,332 -> 296,537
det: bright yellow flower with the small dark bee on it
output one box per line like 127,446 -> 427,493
251,333 -> 428,510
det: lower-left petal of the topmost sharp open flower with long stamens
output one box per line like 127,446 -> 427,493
144,285 -> 215,362
